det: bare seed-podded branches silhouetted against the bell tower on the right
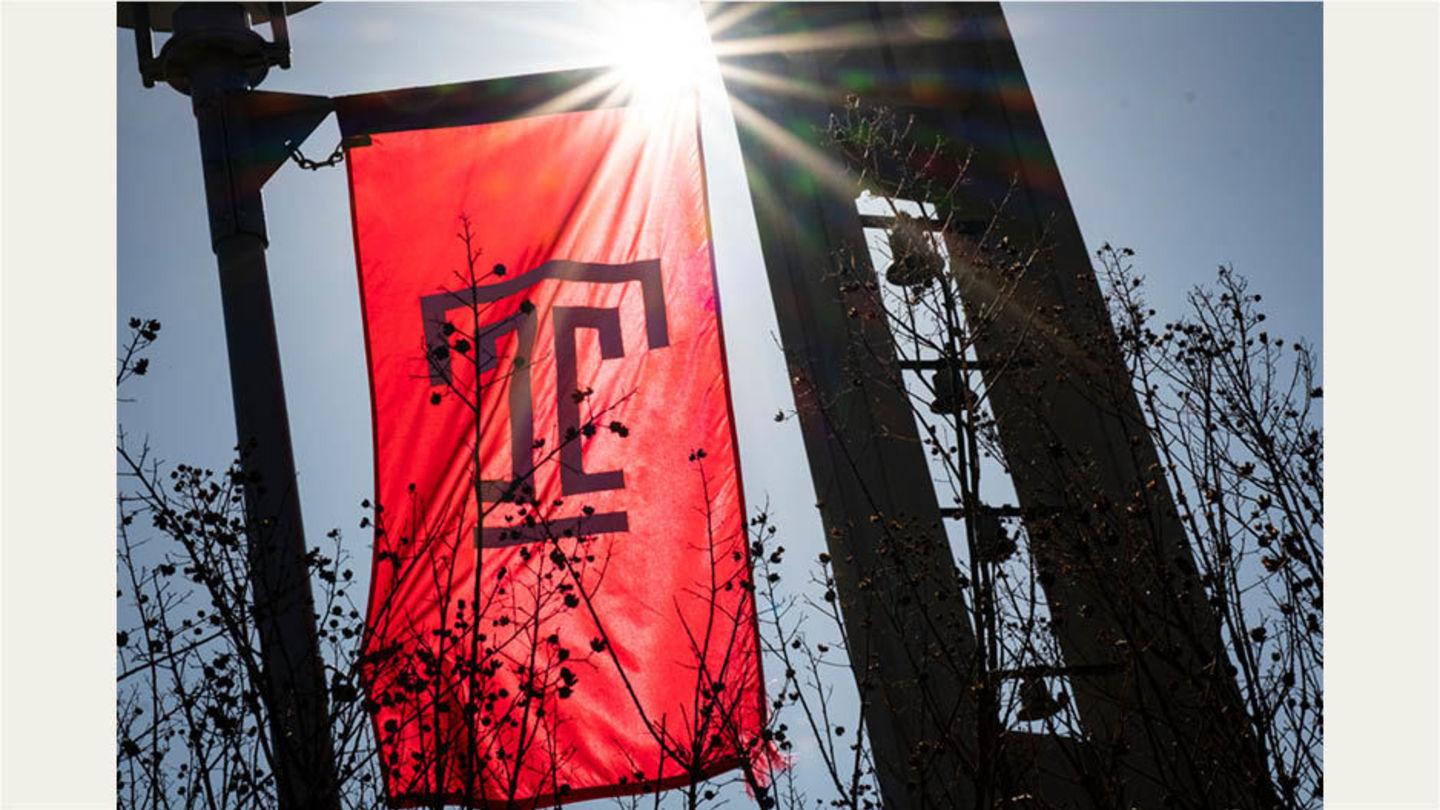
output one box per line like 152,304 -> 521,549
756,99 -> 1323,807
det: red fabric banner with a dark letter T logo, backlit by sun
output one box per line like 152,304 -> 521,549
338,75 -> 765,807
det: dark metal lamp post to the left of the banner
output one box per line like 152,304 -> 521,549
120,3 -> 340,810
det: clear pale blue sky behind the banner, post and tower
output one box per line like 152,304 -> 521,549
115,3 -> 1322,801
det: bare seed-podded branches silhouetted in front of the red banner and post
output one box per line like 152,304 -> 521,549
117,218 -> 769,807
